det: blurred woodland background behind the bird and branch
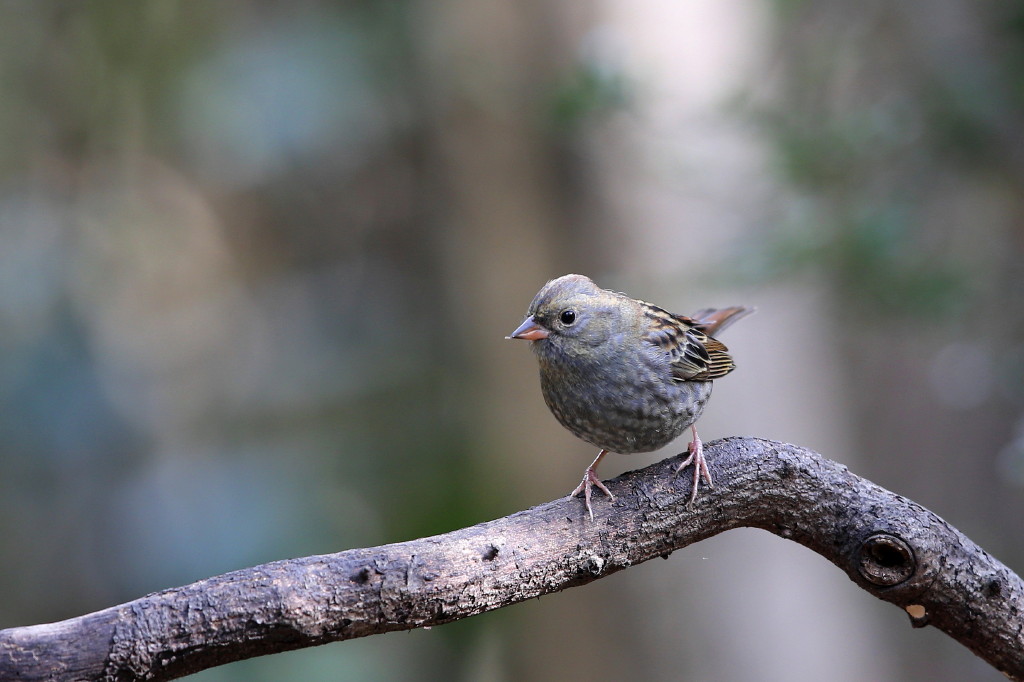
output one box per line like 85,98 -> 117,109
0,0 -> 1024,682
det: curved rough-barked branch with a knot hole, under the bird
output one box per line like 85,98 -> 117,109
0,438 -> 1024,680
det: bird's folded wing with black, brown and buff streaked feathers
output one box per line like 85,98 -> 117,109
644,304 -> 736,381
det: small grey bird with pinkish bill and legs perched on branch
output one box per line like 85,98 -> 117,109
506,274 -> 754,520
